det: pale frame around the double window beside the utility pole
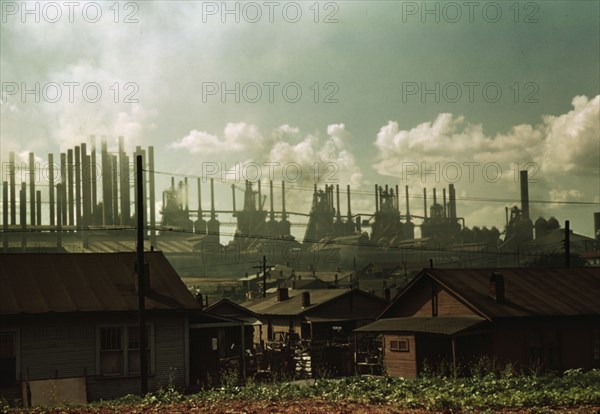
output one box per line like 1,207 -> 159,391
96,323 -> 156,378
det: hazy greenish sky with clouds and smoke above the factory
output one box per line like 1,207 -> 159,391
0,0 -> 600,236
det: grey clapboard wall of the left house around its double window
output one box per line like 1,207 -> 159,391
0,313 -> 186,401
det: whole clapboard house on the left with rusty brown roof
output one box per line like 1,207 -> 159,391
0,252 -> 239,403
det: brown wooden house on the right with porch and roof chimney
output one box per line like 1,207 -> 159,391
355,267 -> 600,377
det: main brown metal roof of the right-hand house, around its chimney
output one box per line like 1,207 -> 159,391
426,267 -> 600,318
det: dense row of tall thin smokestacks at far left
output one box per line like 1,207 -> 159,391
2,135 -> 156,238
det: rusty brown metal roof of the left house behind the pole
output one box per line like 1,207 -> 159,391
0,251 -> 199,316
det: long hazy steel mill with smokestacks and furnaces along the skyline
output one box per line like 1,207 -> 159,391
2,136 -> 600,276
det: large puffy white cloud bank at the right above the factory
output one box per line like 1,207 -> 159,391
373,95 -> 600,234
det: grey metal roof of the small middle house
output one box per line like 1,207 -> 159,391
242,289 -> 350,315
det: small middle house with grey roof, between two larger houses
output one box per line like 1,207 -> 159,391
242,288 -> 387,376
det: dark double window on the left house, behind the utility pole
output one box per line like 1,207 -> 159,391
98,326 -> 152,376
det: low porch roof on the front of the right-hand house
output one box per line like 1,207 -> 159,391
354,316 -> 486,335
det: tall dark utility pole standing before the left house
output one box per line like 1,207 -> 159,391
136,155 -> 148,395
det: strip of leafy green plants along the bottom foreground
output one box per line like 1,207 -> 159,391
5,369 -> 600,412
